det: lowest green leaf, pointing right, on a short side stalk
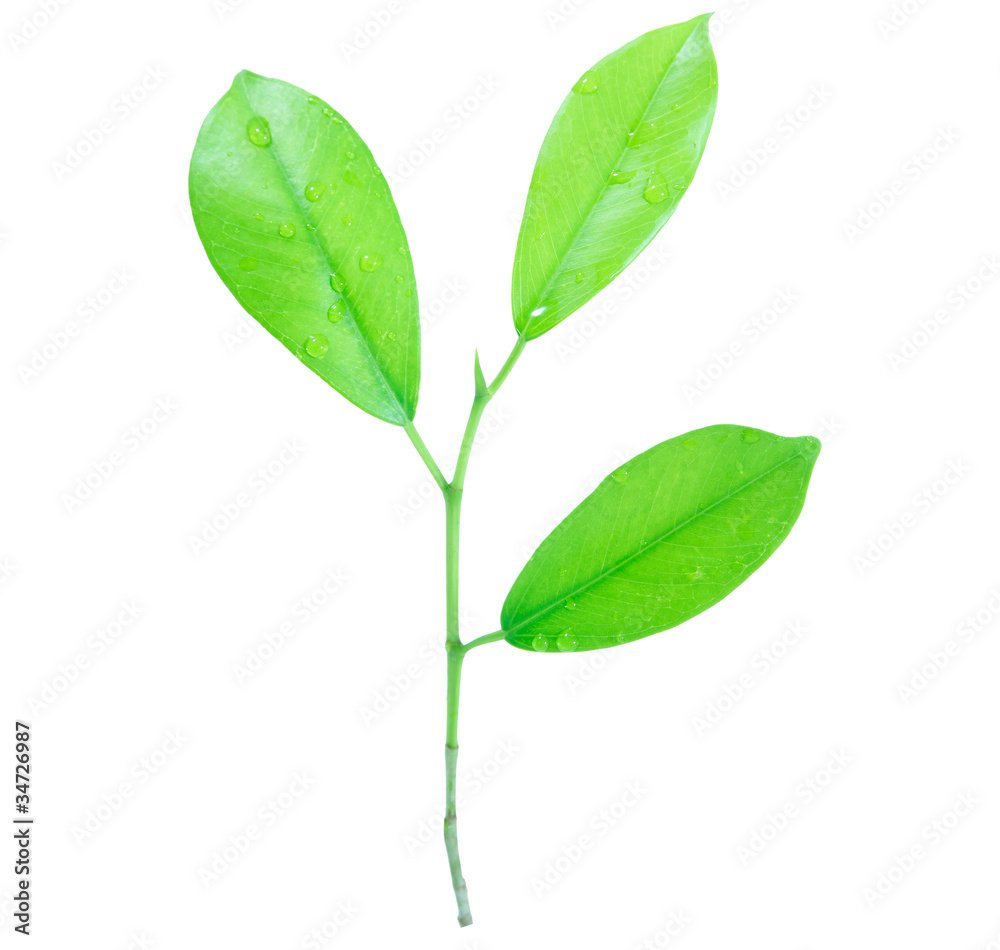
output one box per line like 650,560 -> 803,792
501,425 -> 820,652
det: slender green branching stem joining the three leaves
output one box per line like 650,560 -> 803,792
442,335 -> 528,927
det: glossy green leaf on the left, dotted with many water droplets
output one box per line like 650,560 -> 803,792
190,71 -> 420,425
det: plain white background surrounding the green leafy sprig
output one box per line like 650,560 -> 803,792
0,0 -> 1000,950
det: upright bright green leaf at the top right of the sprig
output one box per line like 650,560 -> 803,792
512,14 -> 718,340
